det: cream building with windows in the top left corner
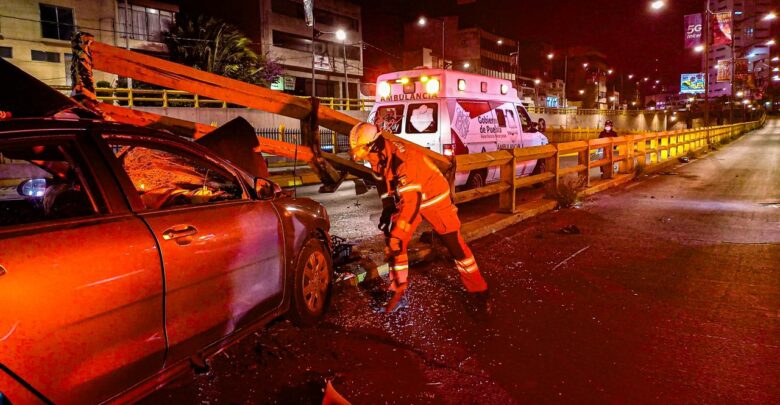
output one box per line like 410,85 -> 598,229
0,0 -> 179,86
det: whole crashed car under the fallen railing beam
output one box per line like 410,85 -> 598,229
0,64 -> 333,404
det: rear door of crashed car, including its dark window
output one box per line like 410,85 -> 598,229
0,129 -> 165,403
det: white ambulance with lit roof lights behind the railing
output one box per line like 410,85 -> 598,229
368,69 -> 548,188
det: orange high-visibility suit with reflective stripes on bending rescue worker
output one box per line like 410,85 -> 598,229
372,140 -> 487,292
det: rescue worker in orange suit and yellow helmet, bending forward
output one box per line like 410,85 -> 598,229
349,122 -> 488,312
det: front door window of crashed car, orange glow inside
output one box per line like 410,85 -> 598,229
109,143 -> 245,210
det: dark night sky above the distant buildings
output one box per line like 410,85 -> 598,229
357,0 -> 704,84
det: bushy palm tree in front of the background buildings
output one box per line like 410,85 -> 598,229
163,14 -> 282,87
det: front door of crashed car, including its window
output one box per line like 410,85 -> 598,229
105,134 -> 284,363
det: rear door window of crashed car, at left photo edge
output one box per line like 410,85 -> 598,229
0,142 -> 97,227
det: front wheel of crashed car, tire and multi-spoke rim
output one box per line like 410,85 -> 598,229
289,239 -> 333,326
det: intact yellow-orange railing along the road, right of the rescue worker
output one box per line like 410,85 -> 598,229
455,118 -> 764,213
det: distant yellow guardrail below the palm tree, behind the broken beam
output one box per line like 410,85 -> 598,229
53,86 -> 374,111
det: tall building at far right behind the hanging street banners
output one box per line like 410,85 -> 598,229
702,0 -> 777,99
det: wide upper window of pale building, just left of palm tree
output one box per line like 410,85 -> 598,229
119,2 -> 175,42
